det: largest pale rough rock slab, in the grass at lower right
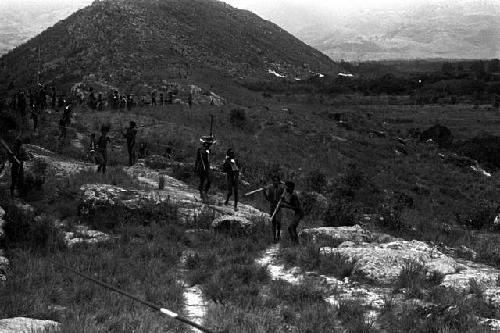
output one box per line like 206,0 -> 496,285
321,241 -> 460,285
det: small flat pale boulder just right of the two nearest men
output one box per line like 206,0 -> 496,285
299,225 -> 373,247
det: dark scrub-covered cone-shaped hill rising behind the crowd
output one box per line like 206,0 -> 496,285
0,0 -> 336,94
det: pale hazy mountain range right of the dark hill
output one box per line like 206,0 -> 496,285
228,0 -> 500,61
